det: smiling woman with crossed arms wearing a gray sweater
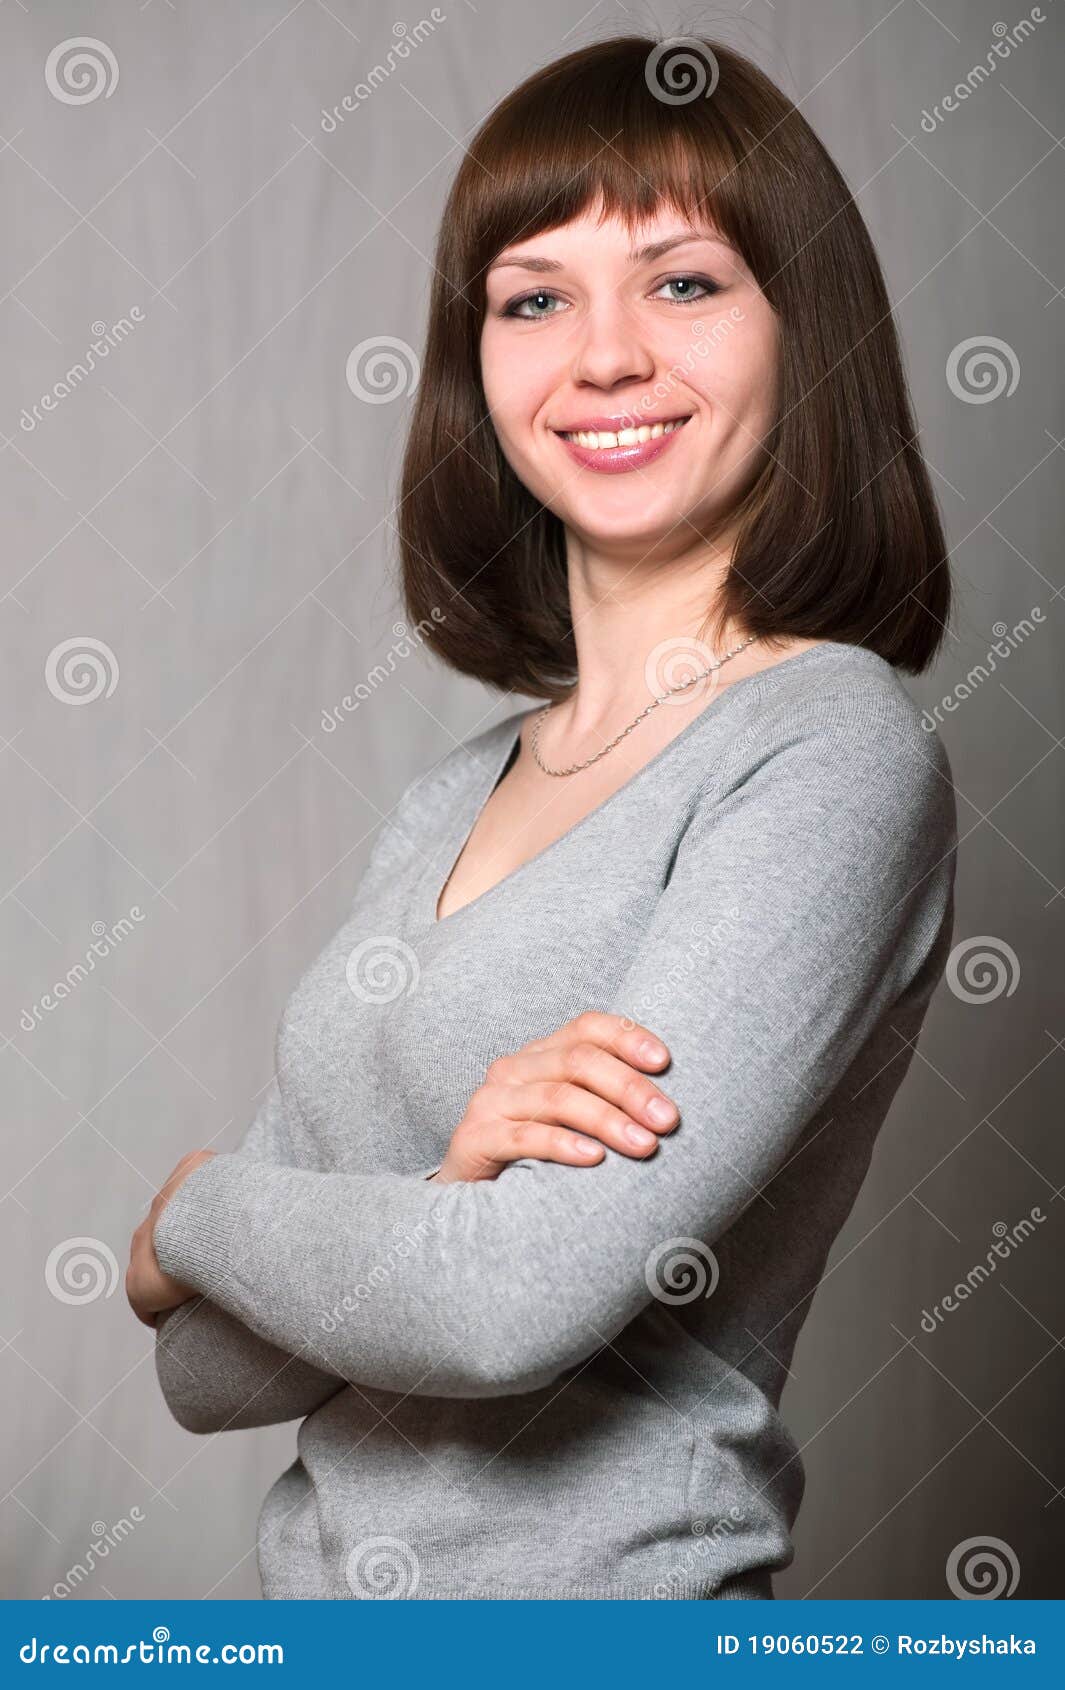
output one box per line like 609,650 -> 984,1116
127,37 -> 957,1599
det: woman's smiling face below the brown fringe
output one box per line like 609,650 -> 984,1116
480,196 -> 778,556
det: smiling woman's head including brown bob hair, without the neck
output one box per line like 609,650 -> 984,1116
399,37 -> 950,700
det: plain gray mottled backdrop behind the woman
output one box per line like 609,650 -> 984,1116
0,0 -> 1065,1599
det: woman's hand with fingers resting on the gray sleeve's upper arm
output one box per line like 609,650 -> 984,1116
433,1009 -> 680,1185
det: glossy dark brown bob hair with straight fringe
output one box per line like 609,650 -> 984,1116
397,35 -> 950,700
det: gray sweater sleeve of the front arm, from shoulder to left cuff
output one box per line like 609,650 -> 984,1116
156,700 -> 957,1398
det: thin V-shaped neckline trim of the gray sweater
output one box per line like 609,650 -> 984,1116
419,641 -> 855,933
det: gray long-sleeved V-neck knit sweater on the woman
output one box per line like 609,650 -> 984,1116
156,642 -> 957,1600
